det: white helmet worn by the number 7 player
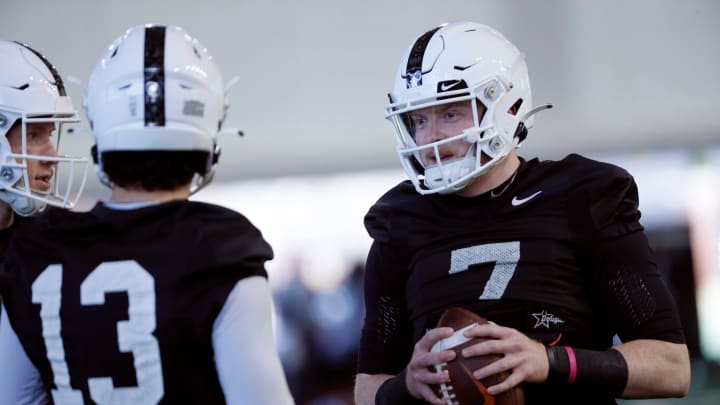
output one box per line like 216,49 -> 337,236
385,22 -> 545,194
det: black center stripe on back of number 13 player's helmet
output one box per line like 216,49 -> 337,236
144,26 -> 165,127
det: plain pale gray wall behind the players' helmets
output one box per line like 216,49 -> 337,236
0,0 -> 720,194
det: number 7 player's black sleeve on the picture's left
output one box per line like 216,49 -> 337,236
358,241 -> 413,374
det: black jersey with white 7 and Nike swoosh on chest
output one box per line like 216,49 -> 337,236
358,155 -> 684,403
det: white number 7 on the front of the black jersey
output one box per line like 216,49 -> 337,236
448,242 -> 520,300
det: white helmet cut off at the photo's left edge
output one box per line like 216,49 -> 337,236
0,40 -> 88,216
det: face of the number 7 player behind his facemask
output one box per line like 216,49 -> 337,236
408,101 -> 485,167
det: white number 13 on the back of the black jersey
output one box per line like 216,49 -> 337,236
32,260 -> 164,404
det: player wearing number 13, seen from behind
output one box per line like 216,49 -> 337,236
0,25 -> 294,404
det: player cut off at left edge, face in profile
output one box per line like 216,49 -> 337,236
0,39 -> 87,340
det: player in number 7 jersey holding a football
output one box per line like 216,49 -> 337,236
355,22 -> 690,404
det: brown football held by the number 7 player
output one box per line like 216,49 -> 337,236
432,308 -> 525,405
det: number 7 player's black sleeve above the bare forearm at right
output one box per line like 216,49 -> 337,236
572,165 -> 685,343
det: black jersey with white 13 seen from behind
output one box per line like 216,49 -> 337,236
0,201 -> 273,404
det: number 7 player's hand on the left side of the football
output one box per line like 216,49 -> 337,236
405,327 -> 455,405
